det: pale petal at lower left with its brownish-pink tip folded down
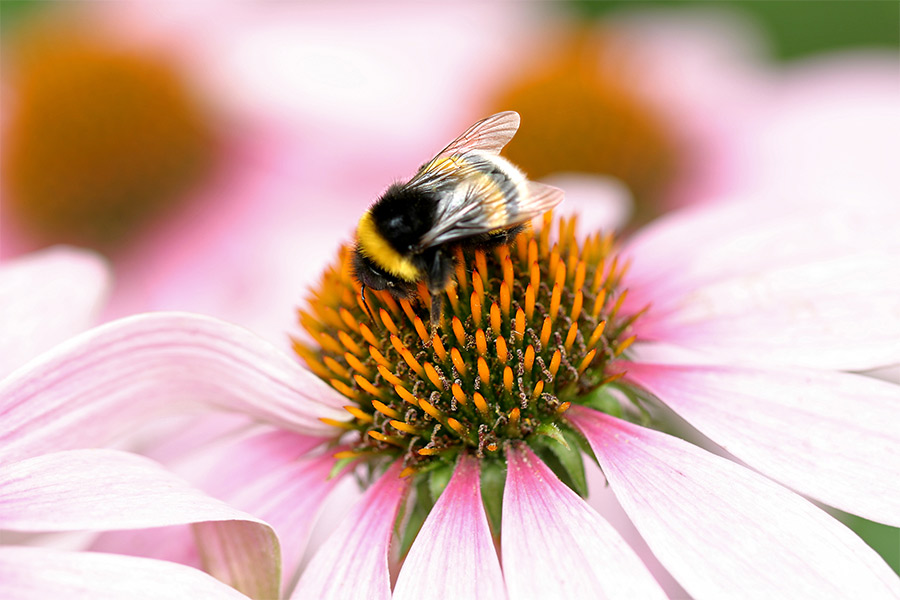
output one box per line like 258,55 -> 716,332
0,450 -> 280,598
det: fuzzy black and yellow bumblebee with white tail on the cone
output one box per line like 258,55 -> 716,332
353,111 -> 563,331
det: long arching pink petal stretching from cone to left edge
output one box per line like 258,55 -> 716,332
0,313 -> 346,458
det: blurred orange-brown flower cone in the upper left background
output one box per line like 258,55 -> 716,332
3,26 -> 214,248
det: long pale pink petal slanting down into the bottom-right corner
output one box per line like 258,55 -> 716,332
570,407 -> 900,598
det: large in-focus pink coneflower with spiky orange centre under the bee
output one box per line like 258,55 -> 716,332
0,200 -> 900,598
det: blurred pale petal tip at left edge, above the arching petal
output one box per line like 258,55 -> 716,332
0,246 -> 110,377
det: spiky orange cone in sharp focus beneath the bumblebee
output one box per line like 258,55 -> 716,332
294,215 -> 636,474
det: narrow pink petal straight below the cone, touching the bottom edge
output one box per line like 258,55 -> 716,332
392,455 -> 506,600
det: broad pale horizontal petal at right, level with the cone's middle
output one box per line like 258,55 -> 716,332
636,251 -> 900,370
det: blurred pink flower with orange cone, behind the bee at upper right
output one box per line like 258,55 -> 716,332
487,7 -> 900,220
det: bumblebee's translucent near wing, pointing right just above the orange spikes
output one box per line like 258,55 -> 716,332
417,181 -> 564,252
